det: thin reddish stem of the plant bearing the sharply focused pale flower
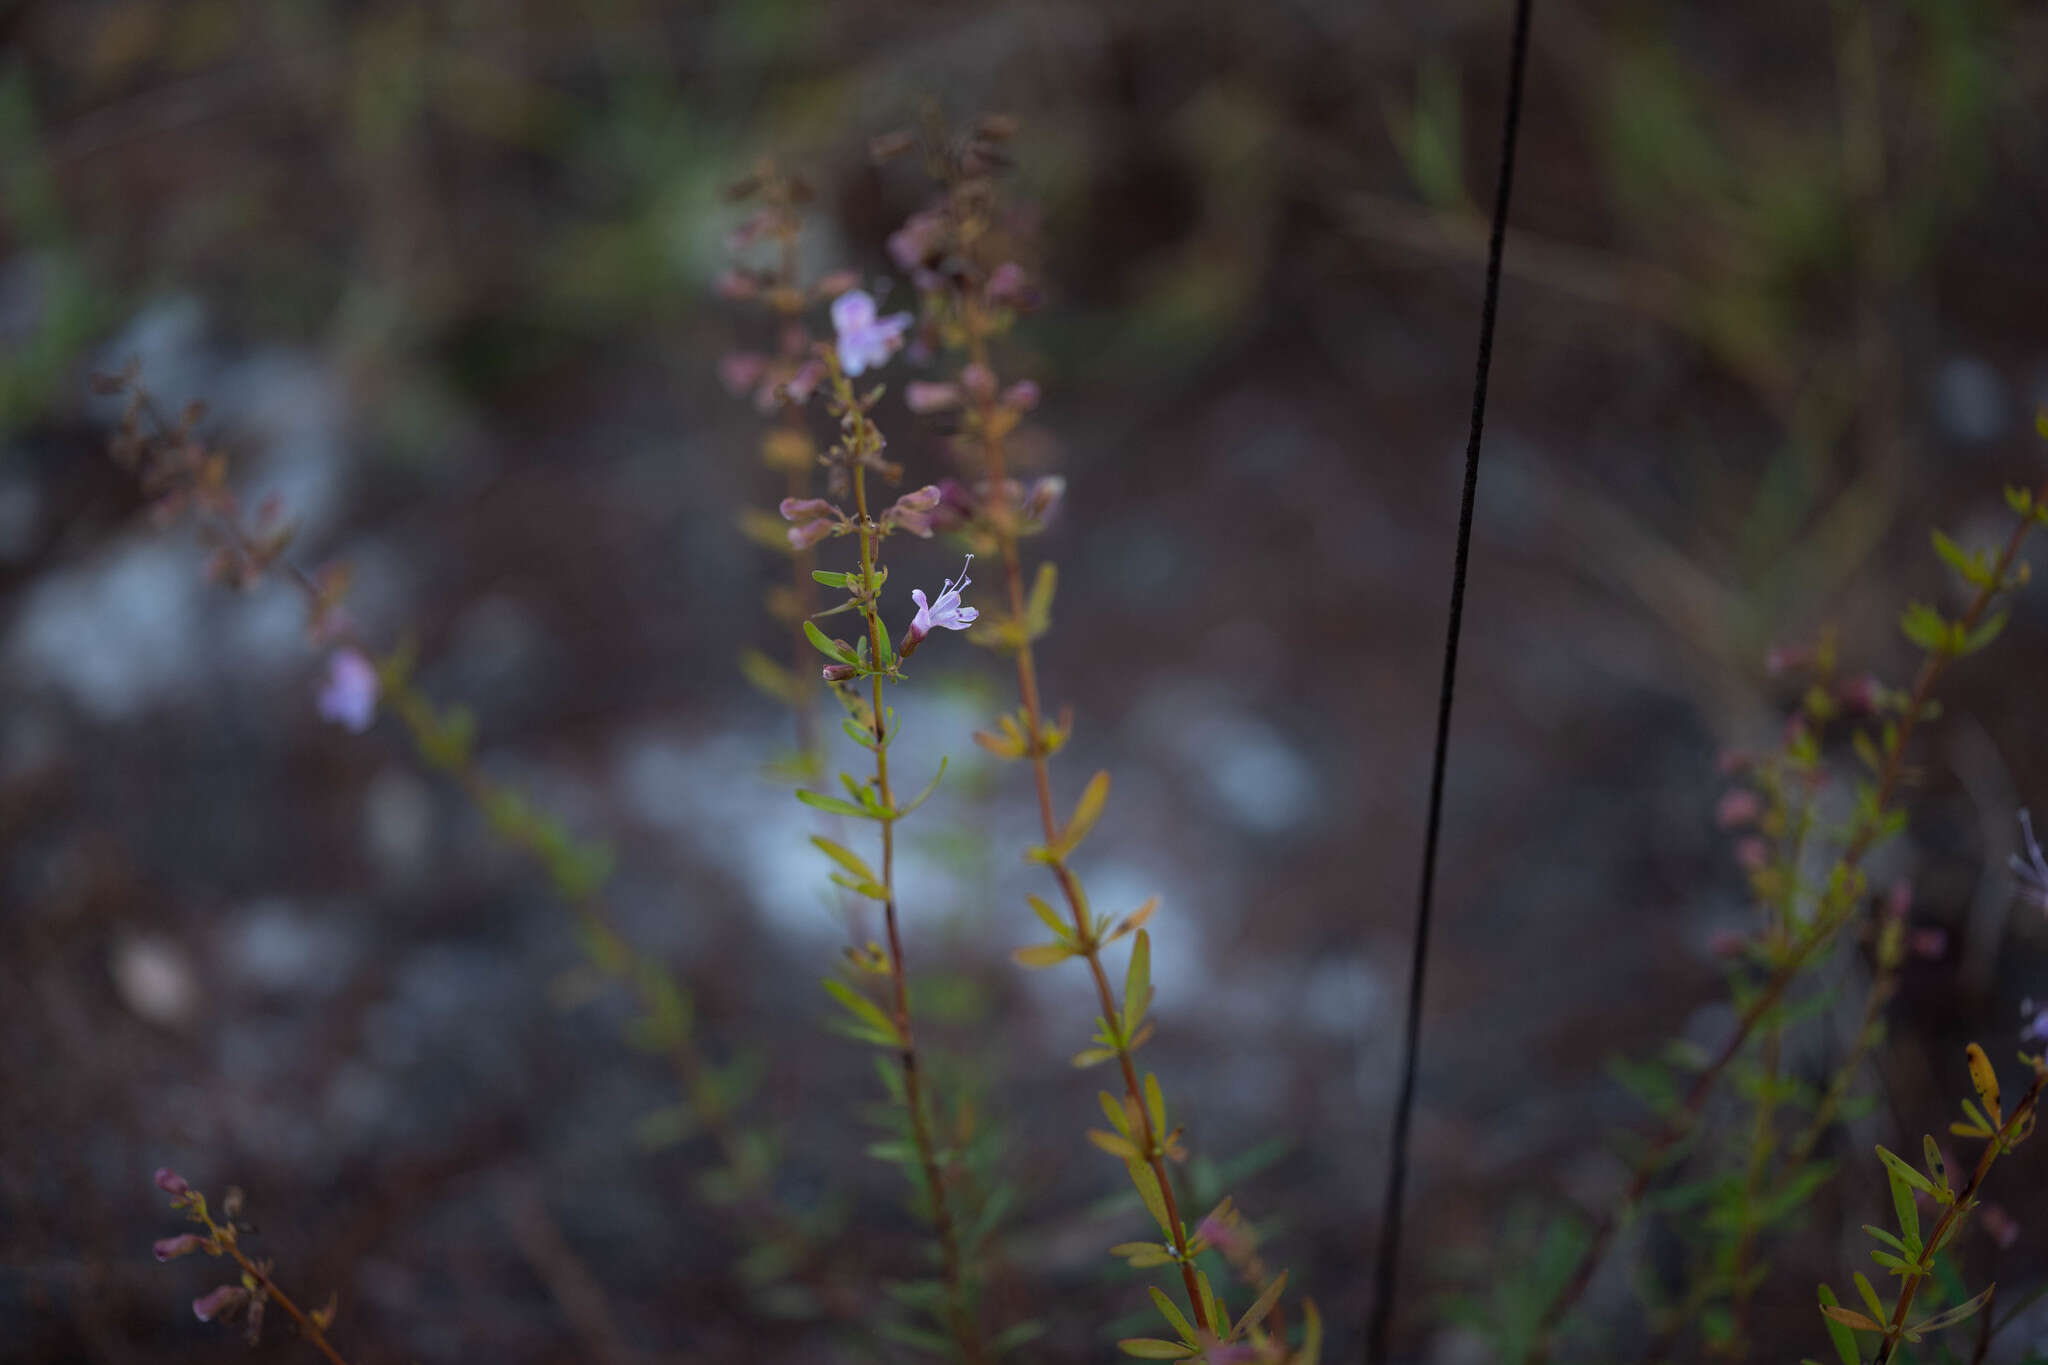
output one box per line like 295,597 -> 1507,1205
854,462 -> 985,1363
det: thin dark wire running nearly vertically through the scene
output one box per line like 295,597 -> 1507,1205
1366,0 -> 1530,1365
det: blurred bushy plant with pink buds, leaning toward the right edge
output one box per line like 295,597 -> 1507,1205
1501,446 -> 2048,1361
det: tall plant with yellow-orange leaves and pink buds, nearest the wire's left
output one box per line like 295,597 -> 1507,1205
874,117 -> 1321,1365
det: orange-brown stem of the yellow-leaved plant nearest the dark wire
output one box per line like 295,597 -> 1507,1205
967,323 -> 1227,1334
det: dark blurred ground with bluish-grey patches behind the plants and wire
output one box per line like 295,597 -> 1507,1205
12,0 -> 2048,1365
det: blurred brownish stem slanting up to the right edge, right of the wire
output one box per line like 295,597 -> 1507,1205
1530,485 -> 2048,1365
